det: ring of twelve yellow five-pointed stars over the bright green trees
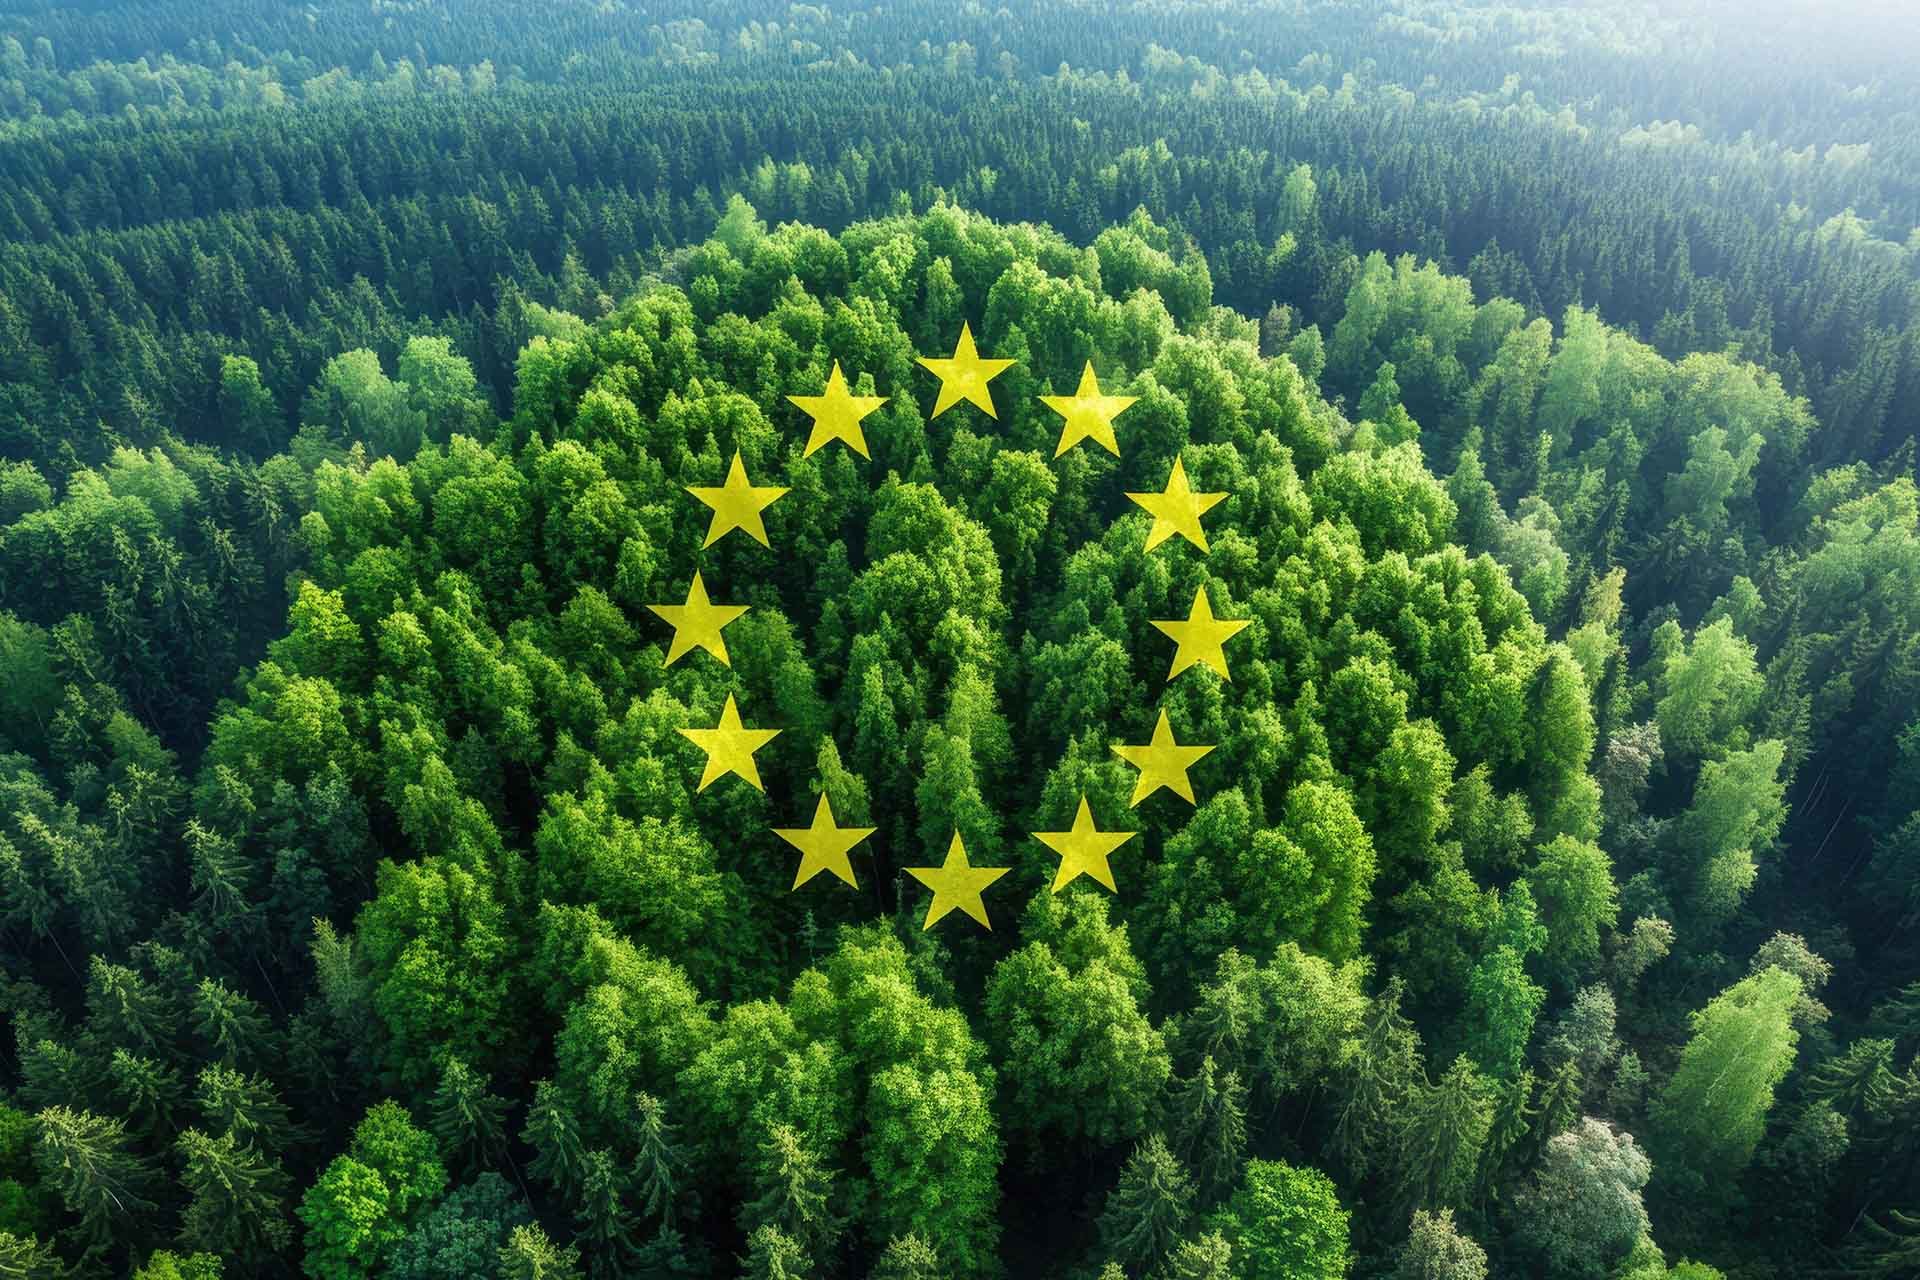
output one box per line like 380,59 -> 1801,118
647,322 -> 1250,929
